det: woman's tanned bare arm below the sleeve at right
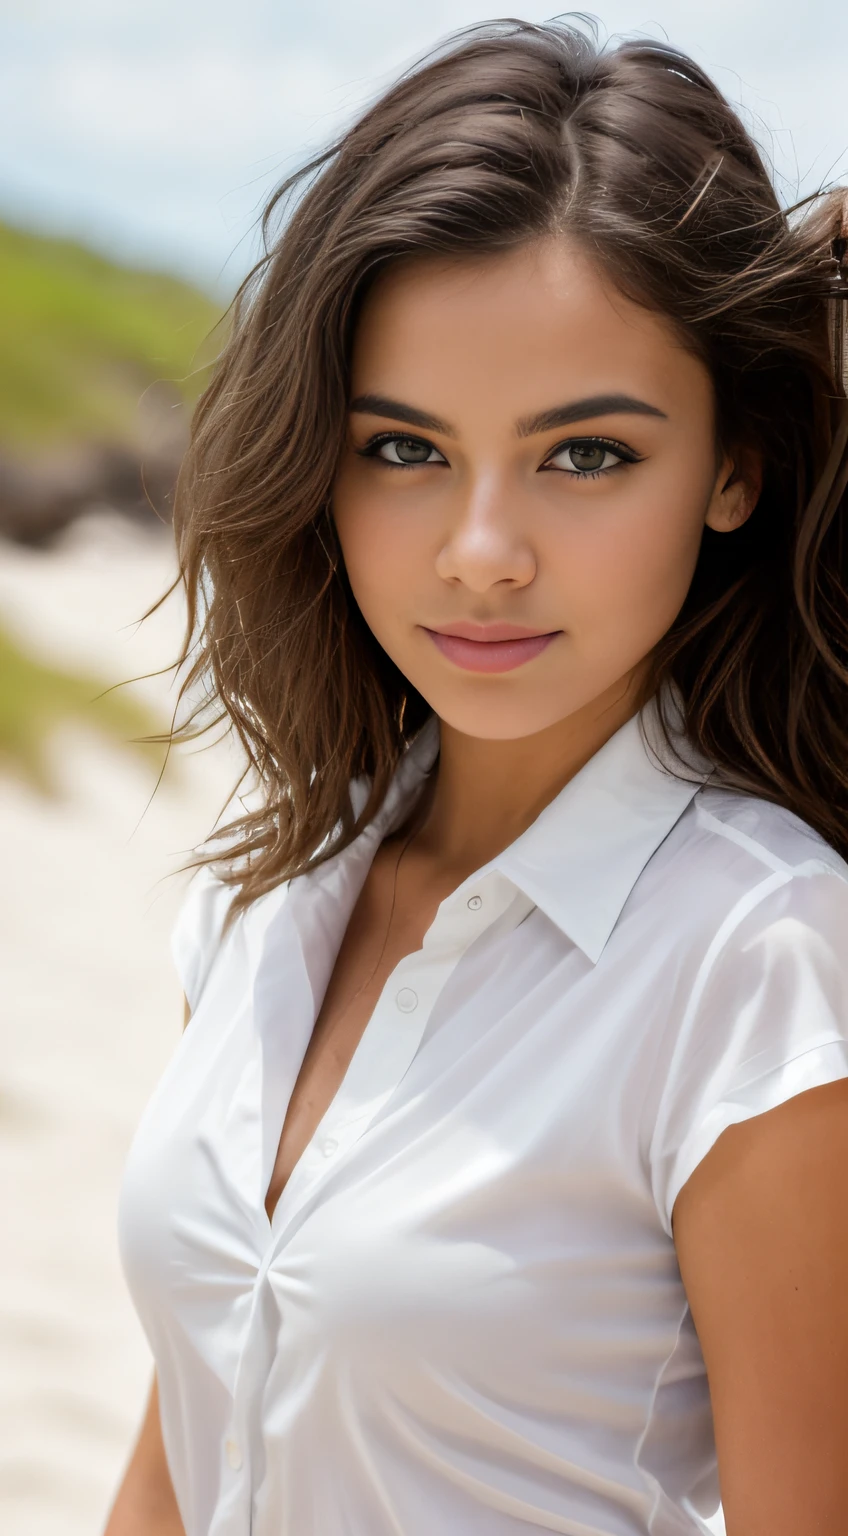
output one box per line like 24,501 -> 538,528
673,1078 -> 848,1536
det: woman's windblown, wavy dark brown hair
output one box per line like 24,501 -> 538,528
175,18 -> 848,911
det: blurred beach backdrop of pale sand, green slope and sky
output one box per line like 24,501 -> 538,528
0,0 -> 848,1536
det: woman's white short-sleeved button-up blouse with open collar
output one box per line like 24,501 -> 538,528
118,700 -> 848,1536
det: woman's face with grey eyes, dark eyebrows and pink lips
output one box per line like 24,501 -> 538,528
333,240 -> 754,740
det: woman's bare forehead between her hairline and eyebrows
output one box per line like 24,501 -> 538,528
347,237 -> 710,417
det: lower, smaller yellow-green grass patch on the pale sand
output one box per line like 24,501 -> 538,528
0,628 -> 164,793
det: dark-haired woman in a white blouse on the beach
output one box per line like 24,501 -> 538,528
109,22 -> 848,1536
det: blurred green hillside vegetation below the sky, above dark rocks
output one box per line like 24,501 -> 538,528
0,224 -> 221,452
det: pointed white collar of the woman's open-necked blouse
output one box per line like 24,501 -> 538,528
372,684 -> 714,965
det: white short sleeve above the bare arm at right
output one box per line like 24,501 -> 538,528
650,866 -> 848,1236
